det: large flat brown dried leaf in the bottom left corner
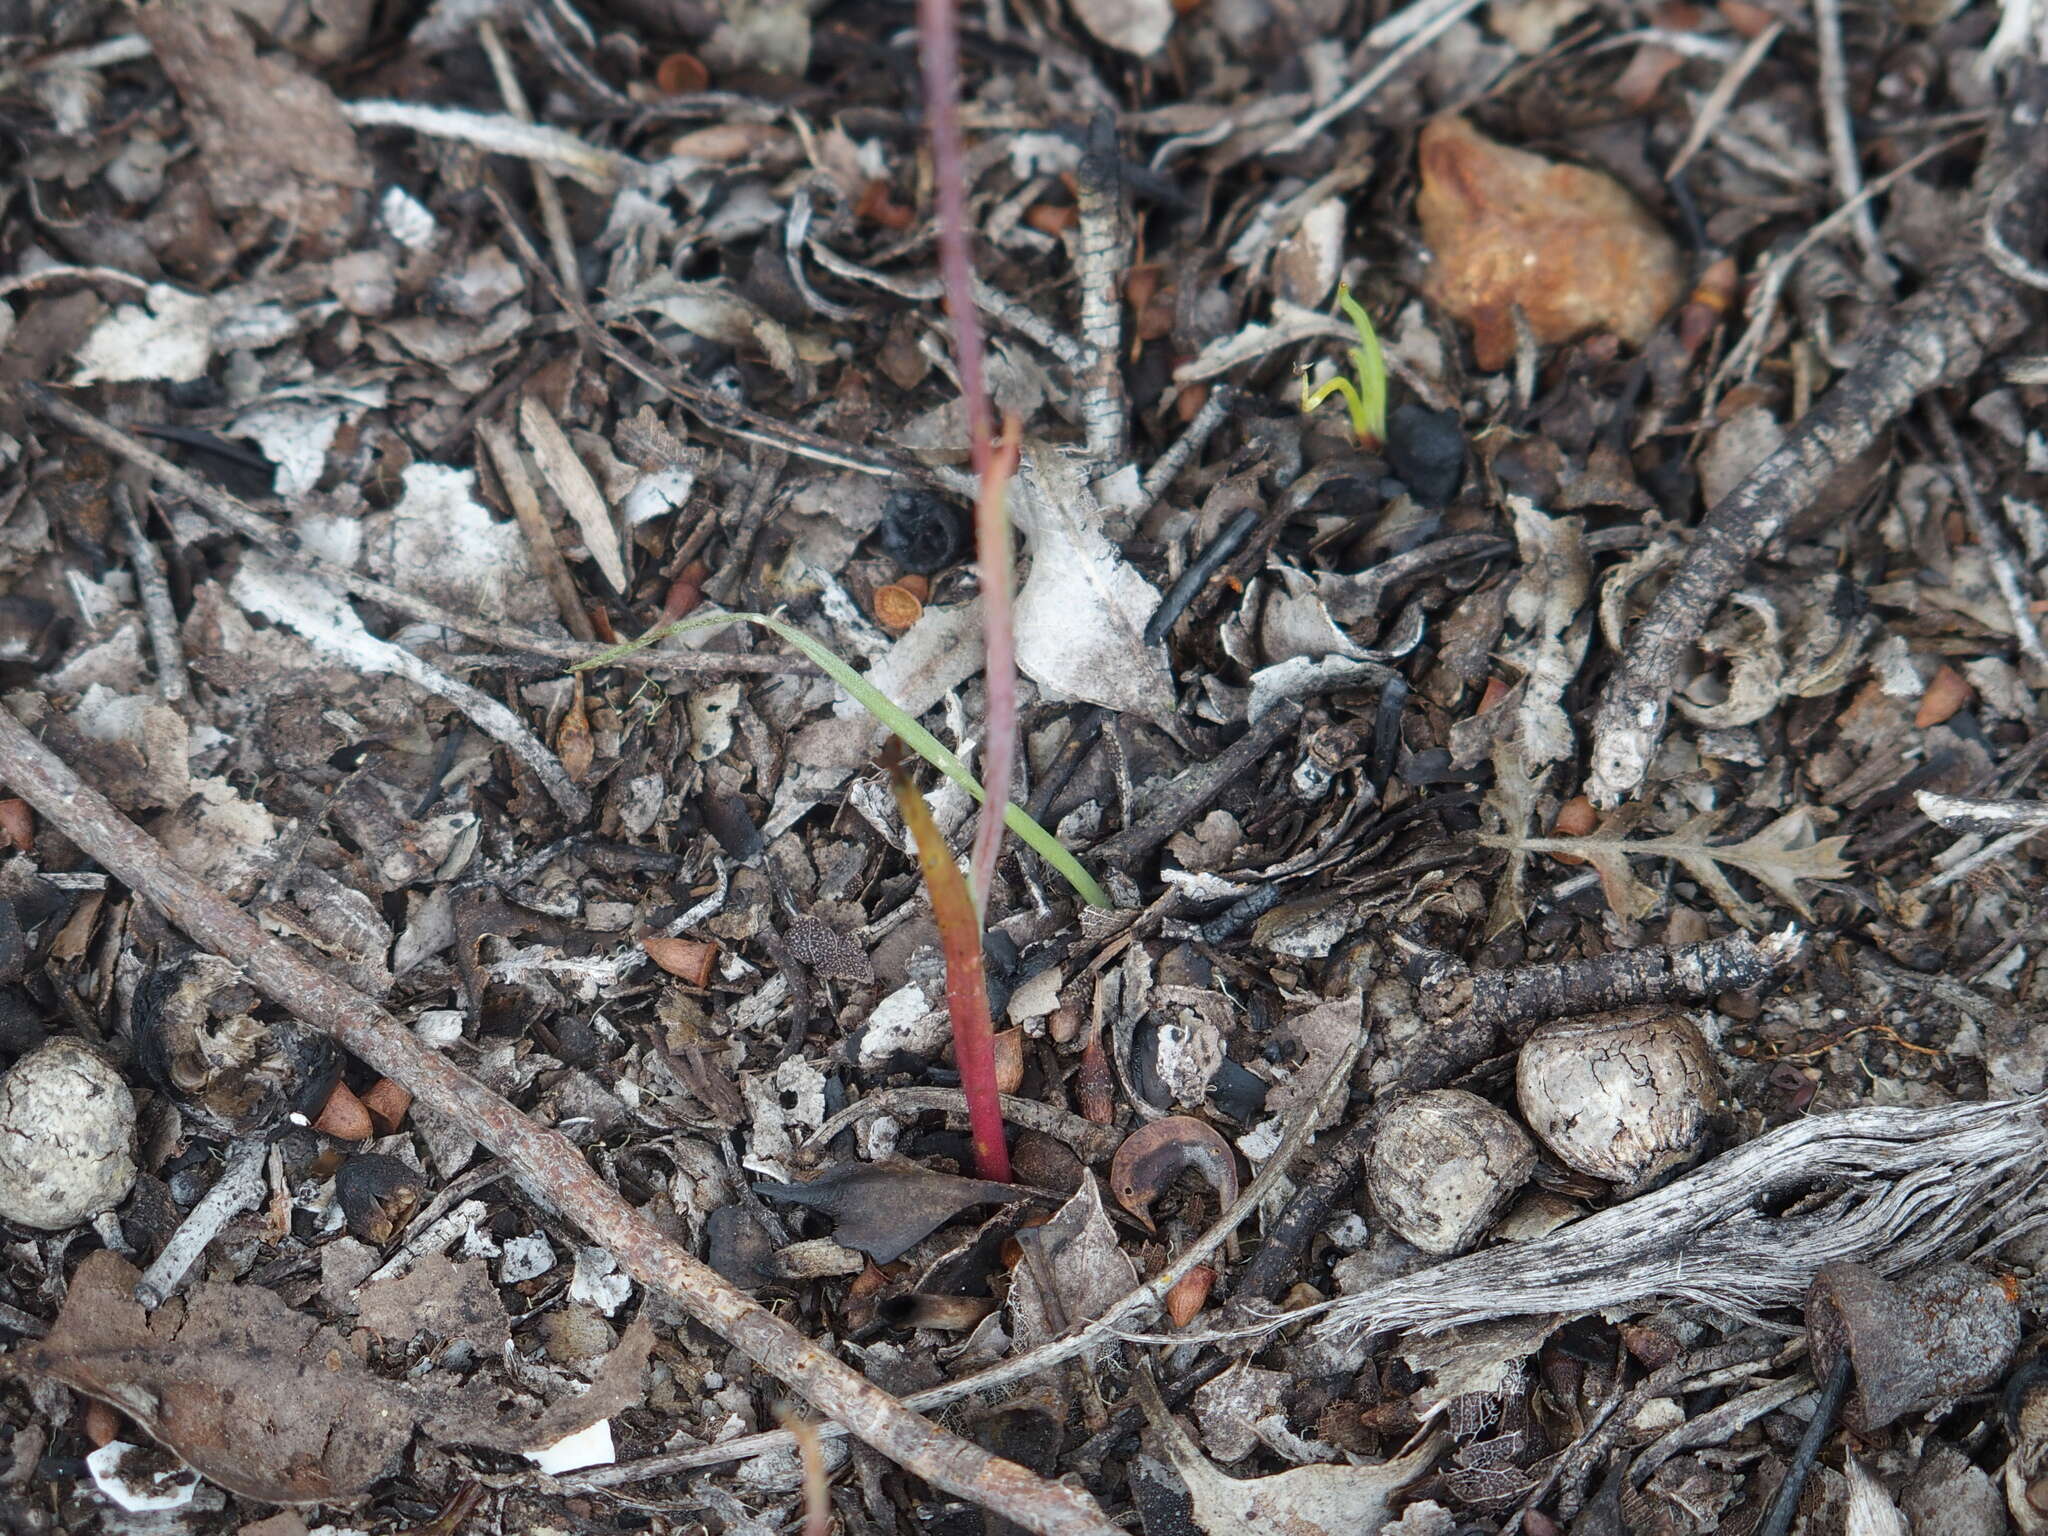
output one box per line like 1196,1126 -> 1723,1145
23,1249 -> 414,1503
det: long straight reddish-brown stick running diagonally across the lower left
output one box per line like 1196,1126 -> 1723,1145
0,709 -> 1120,1536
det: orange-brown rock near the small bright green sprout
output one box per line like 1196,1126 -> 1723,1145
1415,117 -> 1686,371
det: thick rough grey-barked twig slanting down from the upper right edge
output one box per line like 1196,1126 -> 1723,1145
1585,96 -> 2048,807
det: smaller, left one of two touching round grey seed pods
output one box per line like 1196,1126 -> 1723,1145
1366,1087 -> 1536,1253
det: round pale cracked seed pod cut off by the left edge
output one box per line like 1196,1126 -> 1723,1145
0,1036 -> 135,1233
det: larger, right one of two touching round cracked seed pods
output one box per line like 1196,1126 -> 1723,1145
1516,1010 -> 1722,1194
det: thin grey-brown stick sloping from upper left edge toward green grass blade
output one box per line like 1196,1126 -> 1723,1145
20,393 -> 817,674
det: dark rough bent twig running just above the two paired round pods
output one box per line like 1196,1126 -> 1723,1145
1241,934 -> 1802,1300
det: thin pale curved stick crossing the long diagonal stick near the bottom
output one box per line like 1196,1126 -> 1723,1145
575,1003 -> 1366,1489
